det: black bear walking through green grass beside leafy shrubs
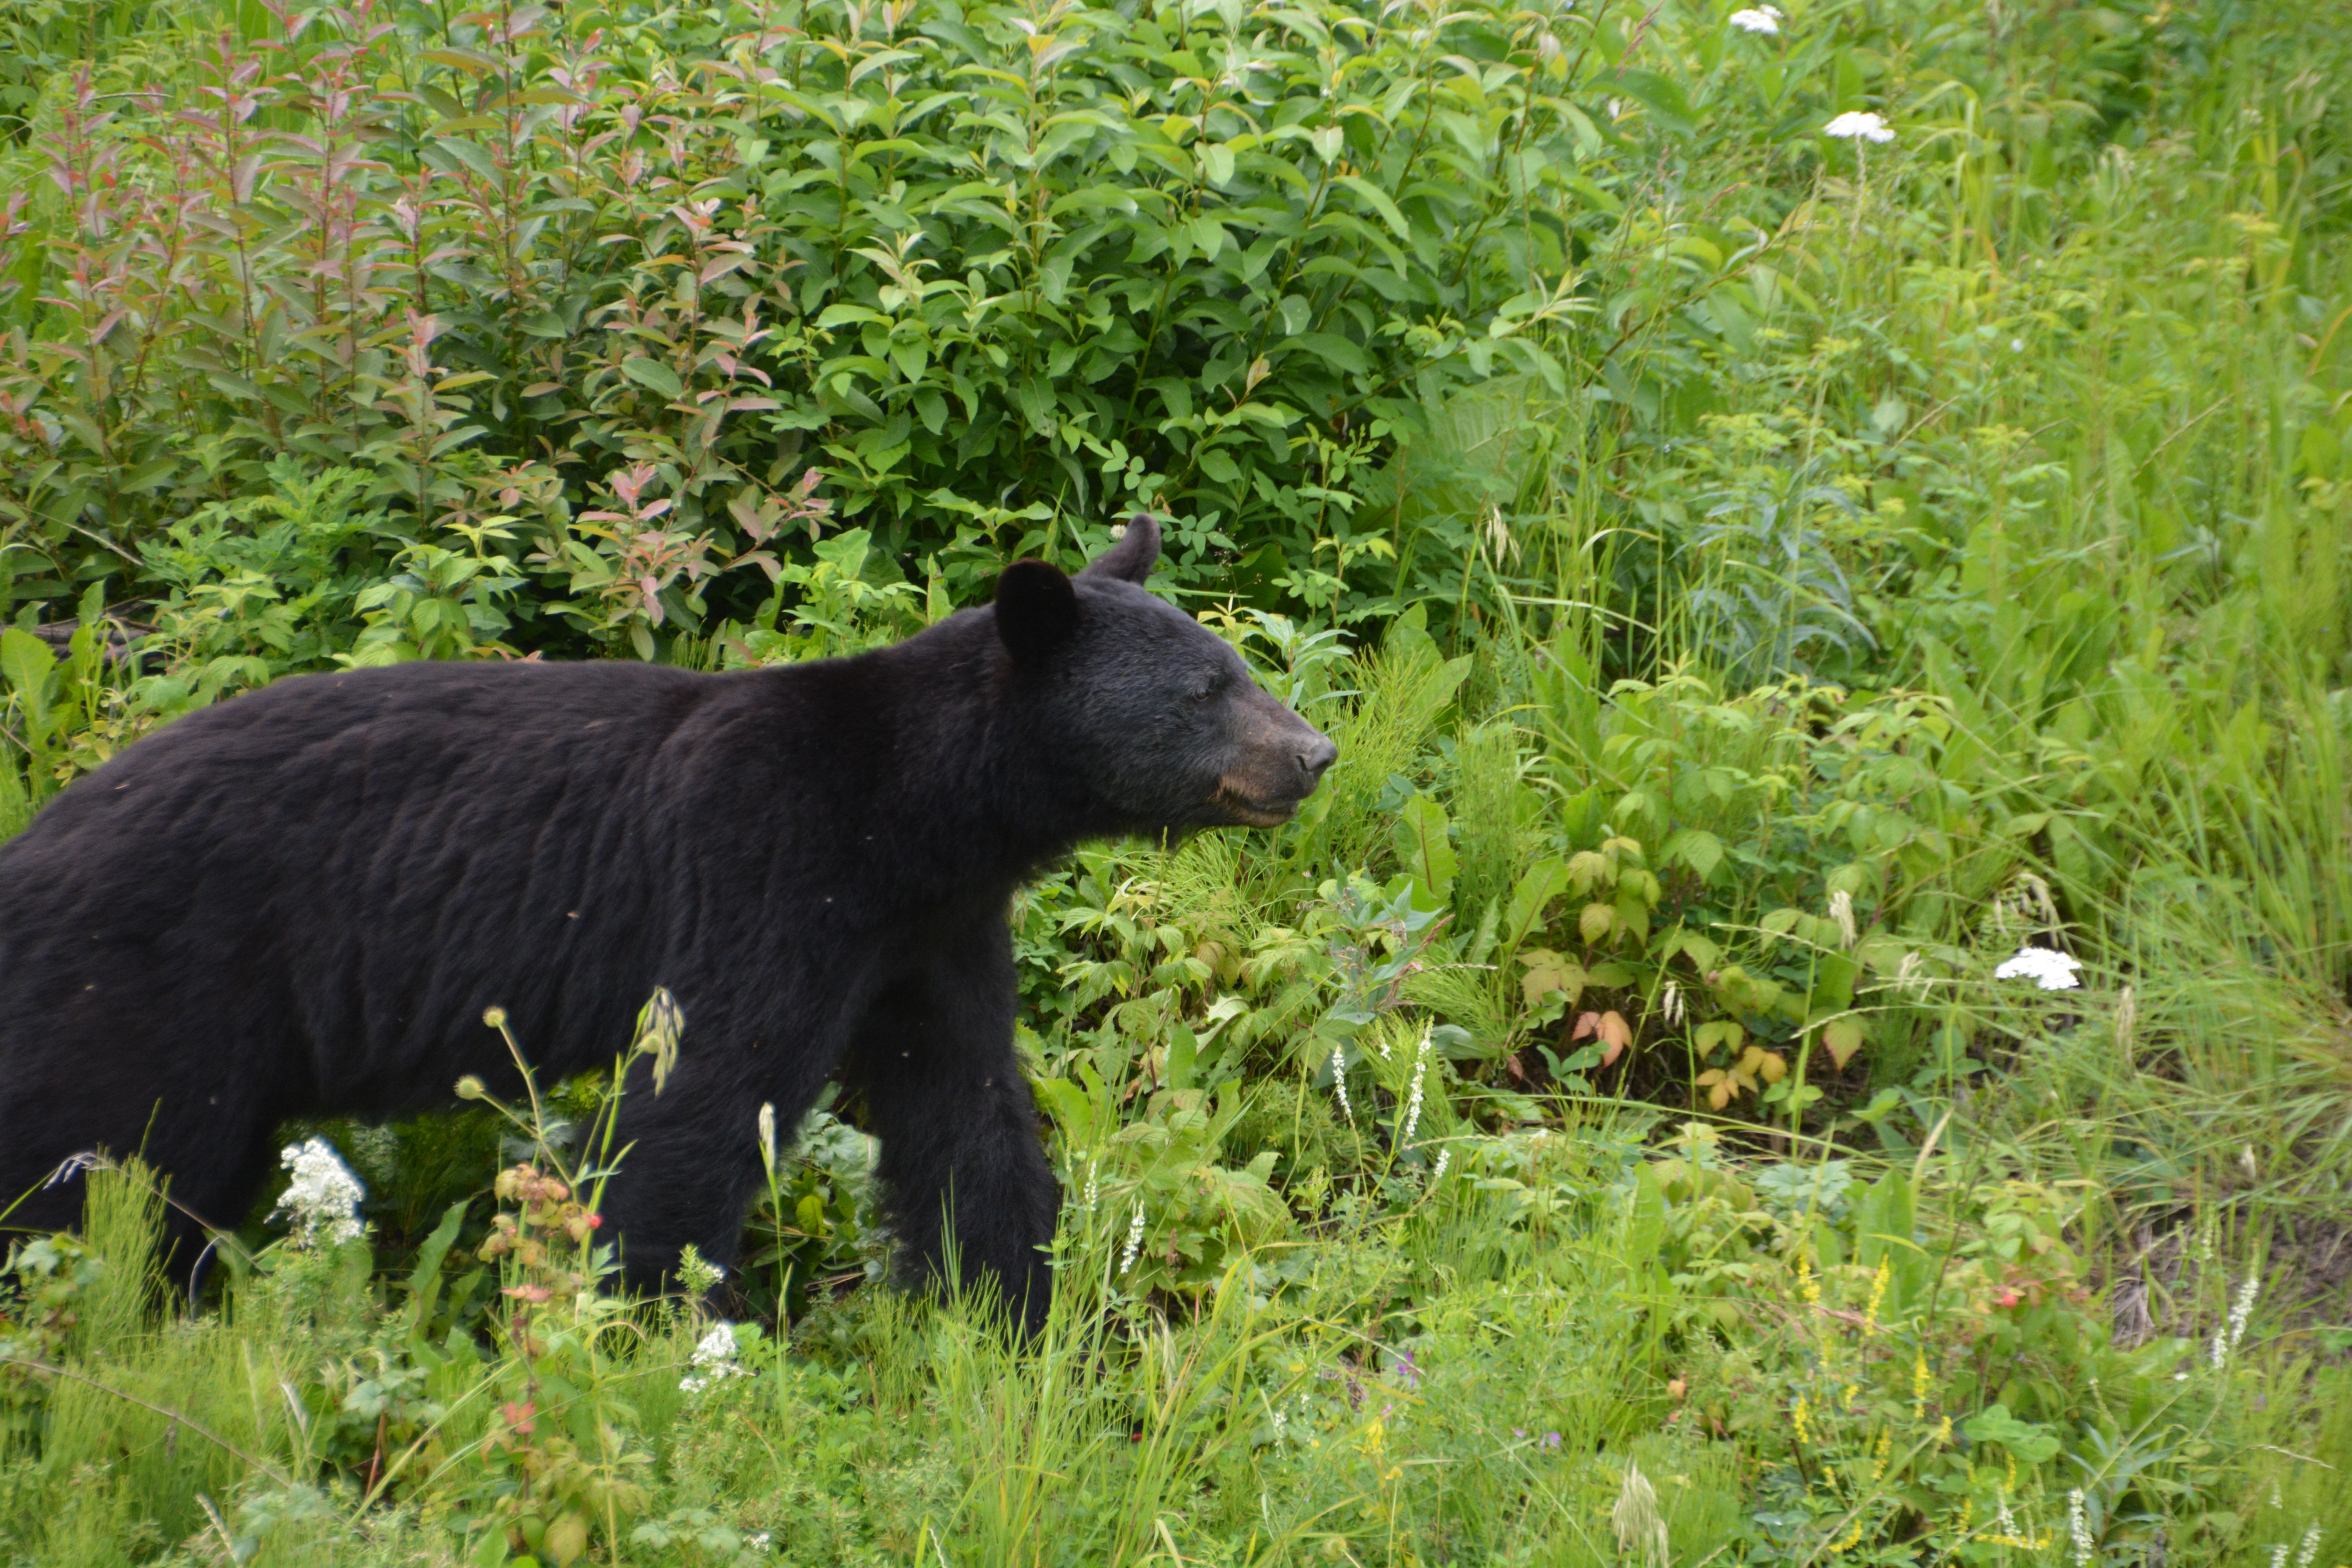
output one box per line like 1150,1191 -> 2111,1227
0,517 -> 1336,1326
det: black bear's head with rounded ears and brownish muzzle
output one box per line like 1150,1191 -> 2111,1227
995,515 -> 1338,832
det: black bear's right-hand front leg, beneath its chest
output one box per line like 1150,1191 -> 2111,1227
844,919 -> 1061,1335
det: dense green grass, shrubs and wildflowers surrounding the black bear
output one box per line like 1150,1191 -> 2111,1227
0,0 -> 2352,1568
